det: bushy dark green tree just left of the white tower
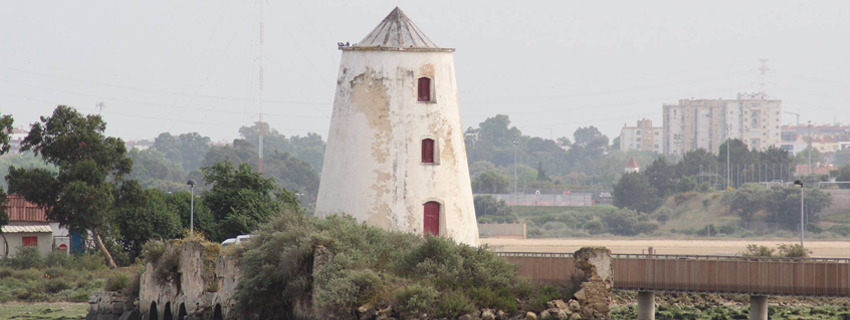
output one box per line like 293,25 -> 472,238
202,161 -> 298,241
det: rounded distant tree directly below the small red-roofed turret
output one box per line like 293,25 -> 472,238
613,173 -> 661,212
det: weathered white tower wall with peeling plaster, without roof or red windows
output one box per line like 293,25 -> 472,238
316,49 -> 478,245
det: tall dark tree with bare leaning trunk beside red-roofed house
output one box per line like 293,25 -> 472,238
6,106 -> 133,268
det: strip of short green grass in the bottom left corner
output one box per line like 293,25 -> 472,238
0,302 -> 89,320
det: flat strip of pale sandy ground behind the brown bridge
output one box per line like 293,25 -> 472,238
479,238 -> 850,258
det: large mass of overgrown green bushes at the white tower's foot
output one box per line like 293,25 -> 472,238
229,213 -> 568,319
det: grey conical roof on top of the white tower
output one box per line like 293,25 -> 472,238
341,7 -> 454,51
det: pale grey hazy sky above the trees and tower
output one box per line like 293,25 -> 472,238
0,0 -> 850,141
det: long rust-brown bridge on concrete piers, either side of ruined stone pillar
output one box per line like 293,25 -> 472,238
498,252 -> 850,319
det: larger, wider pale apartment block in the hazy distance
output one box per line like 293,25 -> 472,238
662,93 -> 782,155
